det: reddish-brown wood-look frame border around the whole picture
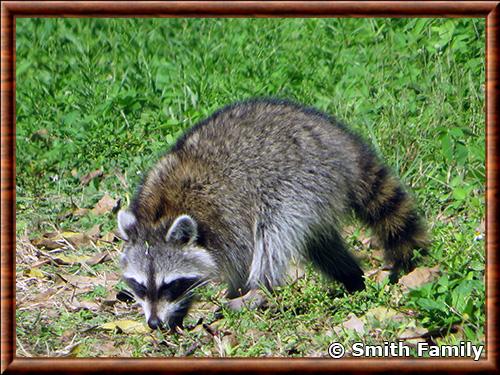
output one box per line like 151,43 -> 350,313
0,1 -> 500,373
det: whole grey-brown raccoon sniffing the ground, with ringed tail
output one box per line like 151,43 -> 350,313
118,99 -> 428,329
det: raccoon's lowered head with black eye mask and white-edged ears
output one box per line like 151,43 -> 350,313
118,210 -> 219,329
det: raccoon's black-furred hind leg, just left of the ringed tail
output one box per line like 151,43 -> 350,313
305,228 -> 365,293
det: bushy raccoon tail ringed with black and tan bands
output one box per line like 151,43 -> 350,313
353,162 -> 428,282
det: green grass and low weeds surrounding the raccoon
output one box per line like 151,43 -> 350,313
16,18 -> 485,356
